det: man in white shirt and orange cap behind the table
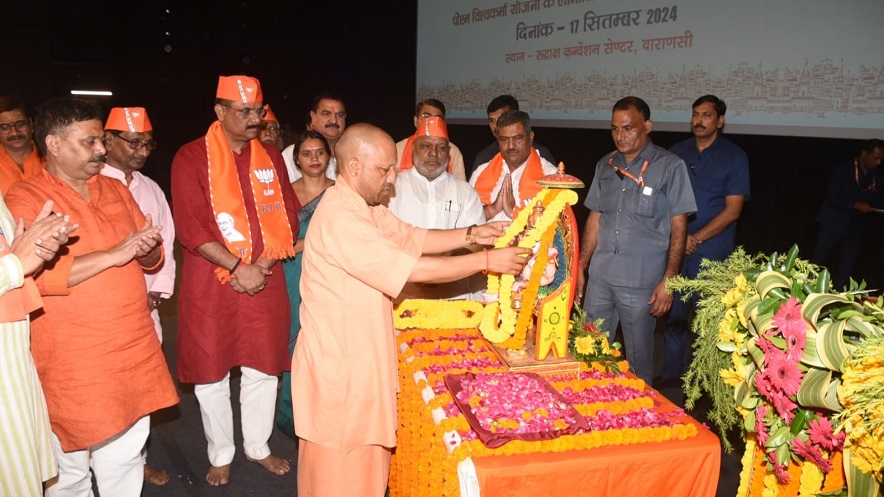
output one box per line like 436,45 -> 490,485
389,116 -> 485,299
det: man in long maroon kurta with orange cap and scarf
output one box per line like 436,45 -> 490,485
172,76 -> 301,486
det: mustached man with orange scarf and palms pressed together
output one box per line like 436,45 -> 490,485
470,110 -> 556,221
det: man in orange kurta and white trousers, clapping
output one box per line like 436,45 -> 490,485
6,99 -> 178,497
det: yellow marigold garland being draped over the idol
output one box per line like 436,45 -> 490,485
479,188 -> 577,349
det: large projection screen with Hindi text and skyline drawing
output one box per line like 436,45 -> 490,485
416,0 -> 884,138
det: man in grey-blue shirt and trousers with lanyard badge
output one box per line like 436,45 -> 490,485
578,97 -> 696,383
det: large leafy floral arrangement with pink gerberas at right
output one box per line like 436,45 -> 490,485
667,247 -> 884,497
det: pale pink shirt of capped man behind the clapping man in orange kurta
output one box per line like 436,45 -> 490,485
101,164 -> 175,342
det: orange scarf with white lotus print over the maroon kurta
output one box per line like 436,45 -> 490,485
206,121 -> 295,283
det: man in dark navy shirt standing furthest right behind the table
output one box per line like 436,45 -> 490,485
659,95 -> 749,386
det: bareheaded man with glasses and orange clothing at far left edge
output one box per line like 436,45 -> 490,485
0,96 -> 44,195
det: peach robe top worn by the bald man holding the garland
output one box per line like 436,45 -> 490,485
292,181 -> 427,452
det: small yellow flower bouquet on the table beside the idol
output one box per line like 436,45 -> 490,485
568,306 -> 629,373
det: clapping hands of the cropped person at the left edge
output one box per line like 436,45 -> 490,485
10,200 -> 78,275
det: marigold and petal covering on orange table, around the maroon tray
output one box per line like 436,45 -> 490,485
390,328 -> 699,497
